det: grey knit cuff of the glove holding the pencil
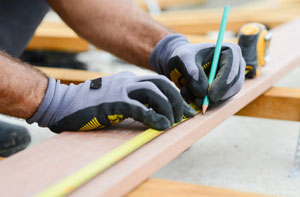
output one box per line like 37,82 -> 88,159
149,34 -> 189,75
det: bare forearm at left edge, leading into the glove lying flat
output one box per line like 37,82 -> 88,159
0,51 -> 48,119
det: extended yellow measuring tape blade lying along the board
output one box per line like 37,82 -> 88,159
37,104 -> 200,197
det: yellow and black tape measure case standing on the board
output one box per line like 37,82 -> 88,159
238,23 -> 272,78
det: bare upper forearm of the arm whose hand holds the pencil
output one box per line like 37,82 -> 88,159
48,0 -> 172,68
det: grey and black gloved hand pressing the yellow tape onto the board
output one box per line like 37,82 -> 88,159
27,72 -> 196,133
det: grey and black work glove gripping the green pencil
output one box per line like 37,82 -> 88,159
149,34 -> 245,107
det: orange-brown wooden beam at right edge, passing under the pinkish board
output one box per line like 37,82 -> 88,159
236,87 -> 300,121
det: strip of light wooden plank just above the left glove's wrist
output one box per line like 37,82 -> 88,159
36,67 -> 108,84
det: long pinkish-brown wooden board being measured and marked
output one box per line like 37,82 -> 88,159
0,20 -> 300,196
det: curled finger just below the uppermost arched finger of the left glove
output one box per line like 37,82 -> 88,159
127,81 -> 174,124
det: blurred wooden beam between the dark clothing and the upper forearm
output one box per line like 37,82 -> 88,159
27,22 -> 89,52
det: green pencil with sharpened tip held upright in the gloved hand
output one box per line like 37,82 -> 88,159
202,5 -> 230,114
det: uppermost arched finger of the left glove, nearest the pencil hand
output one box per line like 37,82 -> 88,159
139,76 -> 183,122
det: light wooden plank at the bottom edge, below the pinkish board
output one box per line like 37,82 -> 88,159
126,178 -> 267,197
